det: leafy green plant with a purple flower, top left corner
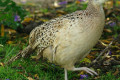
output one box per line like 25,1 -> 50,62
0,0 -> 26,29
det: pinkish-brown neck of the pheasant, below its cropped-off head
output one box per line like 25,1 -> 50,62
87,1 -> 104,14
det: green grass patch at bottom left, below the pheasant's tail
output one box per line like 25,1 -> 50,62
0,59 -> 64,80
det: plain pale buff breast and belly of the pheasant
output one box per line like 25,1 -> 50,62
53,16 -> 104,65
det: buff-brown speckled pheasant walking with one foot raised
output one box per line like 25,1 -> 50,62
7,0 -> 107,80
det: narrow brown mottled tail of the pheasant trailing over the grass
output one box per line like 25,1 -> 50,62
5,45 -> 33,64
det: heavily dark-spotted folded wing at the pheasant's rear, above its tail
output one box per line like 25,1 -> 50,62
29,18 -> 67,49
